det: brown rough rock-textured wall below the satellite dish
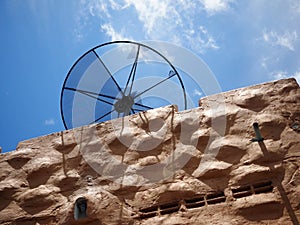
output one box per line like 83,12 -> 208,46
0,79 -> 300,225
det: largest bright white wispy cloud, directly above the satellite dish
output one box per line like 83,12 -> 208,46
126,0 -> 219,53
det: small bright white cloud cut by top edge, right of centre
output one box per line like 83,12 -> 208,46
200,0 -> 234,15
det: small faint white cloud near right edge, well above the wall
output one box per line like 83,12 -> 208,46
262,31 -> 298,51
